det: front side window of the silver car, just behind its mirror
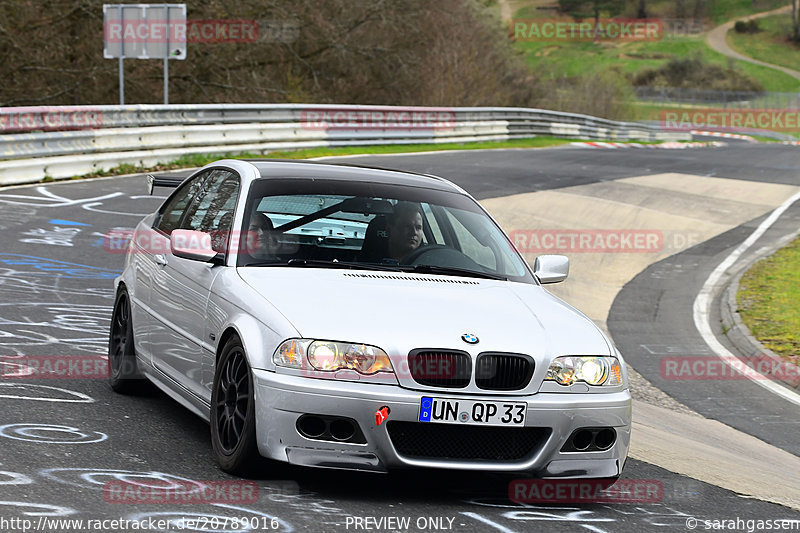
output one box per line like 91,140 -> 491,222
181,169 -> 239,253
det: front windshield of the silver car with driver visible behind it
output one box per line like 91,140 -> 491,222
238,178 -> 535,283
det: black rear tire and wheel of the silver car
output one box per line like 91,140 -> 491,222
108,288 -> 144,394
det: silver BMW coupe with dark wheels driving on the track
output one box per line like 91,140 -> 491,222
109,160 -> 631,478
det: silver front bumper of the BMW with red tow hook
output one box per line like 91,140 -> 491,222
253,370 -> 631,478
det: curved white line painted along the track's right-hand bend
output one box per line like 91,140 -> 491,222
693,192 -> 800,406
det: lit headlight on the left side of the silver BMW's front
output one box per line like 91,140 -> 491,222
272,339 -> 394,375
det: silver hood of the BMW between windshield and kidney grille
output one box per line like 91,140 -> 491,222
238,267 -> 611,362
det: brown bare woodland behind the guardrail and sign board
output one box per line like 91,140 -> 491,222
0,0 -> 531,106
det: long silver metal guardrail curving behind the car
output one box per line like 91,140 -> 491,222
0,104 -> 690,184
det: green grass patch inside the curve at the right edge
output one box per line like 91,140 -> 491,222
736,238 -> 800,364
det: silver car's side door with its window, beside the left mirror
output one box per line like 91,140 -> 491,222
150,168 -> 239,401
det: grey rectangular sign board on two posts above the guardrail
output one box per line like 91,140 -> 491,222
103,4 -> 186,59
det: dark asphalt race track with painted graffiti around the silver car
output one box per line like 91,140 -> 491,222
0,143 -> 800,533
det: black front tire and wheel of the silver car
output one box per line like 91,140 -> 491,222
211,337 -> 259,475
